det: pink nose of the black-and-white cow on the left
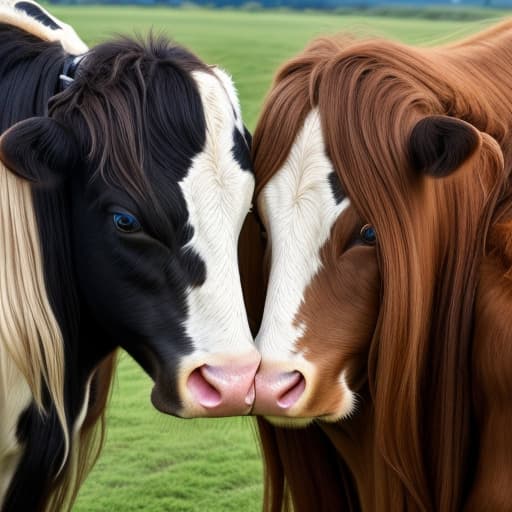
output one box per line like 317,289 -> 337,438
187,354 -> 260,416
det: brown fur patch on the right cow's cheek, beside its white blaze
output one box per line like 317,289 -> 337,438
296,209 -> 380,417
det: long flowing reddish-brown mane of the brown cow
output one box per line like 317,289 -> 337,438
253,22 -> 512,511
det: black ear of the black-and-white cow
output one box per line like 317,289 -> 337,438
0,117 -> 78,187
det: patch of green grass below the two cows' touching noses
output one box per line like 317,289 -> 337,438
74,354 -> 261,512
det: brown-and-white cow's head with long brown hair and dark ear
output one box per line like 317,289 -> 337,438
248,38 -> 503,432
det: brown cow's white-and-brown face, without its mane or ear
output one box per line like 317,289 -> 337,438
254,110 -> 380,425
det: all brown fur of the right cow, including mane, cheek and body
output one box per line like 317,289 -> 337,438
253,22 -> 512,512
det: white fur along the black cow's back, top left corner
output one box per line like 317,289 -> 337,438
0,0 -> 88,55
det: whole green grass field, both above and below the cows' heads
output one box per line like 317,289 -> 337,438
50,6 -> 512,512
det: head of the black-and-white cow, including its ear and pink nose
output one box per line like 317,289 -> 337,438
0,40 -> 260,417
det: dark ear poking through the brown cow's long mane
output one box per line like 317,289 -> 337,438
409,116 -> 481,178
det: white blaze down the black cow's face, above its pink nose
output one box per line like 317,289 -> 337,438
180,70 -> 254,407
